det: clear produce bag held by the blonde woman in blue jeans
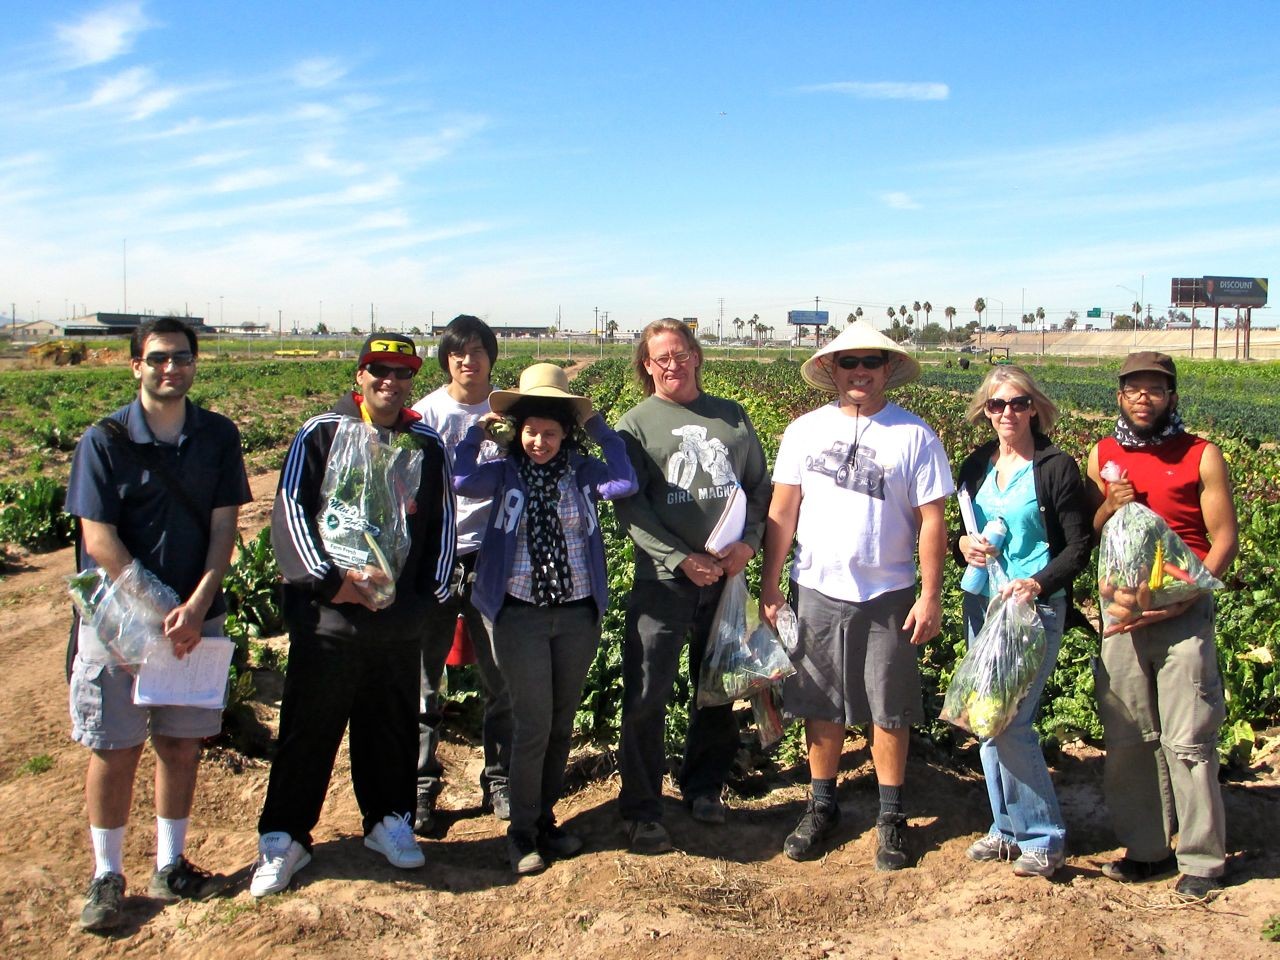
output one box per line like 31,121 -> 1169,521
942,595 -> 1044,739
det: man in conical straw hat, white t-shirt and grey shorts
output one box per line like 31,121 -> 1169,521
760,321 -> 955,870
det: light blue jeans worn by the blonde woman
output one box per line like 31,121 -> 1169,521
964,593 -> 1066,856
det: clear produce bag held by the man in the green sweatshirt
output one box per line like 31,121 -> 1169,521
698,573 -> 796,707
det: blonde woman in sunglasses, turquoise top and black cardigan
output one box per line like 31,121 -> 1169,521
956,365 -> 1092,877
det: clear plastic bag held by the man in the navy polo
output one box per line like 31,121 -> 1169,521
68,561 -> 182,667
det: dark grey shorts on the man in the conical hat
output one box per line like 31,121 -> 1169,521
782,584 -> 924,730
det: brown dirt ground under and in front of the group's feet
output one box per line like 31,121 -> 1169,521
0,476 -> 1280,960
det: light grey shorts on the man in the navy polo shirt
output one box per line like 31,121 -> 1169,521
70,616 -> 224,750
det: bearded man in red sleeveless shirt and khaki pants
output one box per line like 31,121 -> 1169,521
1088,351 -> 1238,900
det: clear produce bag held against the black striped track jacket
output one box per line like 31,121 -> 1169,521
316,417 -> 422,609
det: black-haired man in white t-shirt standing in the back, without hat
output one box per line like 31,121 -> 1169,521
413,314 -> 511,833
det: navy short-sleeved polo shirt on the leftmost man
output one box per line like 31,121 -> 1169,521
67,399 -> 252,617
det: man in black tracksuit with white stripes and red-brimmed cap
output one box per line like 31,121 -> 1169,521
250,333 -> 454,897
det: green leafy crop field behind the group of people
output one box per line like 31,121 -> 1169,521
0,343 -> 1280,762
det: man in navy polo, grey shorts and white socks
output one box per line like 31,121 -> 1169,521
67,317 -> 251,932
